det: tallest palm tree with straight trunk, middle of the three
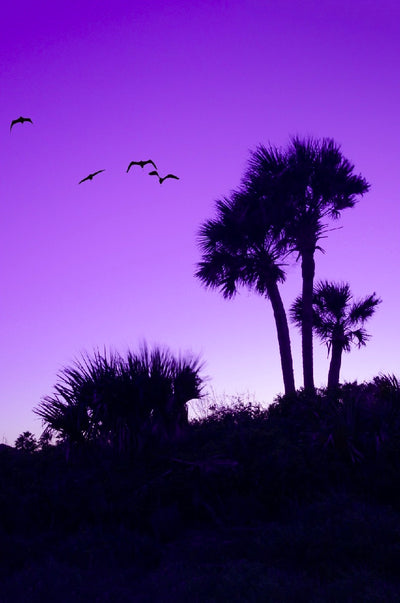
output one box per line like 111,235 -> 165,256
242,137 -> 369,389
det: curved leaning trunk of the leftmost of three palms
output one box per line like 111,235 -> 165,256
267,282 -> 296,394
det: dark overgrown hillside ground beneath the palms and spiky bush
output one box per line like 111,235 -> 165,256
0,376 -> 400,603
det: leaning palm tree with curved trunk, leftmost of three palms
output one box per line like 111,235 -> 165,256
195,192 -> 295,393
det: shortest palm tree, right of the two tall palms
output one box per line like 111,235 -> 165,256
290,281 -> 381,387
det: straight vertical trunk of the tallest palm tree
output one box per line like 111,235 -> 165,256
301,250 -> 315,389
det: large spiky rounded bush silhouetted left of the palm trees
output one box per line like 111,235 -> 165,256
34,344 -> 203,452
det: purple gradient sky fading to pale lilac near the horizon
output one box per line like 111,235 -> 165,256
0,0 -> 400,444
